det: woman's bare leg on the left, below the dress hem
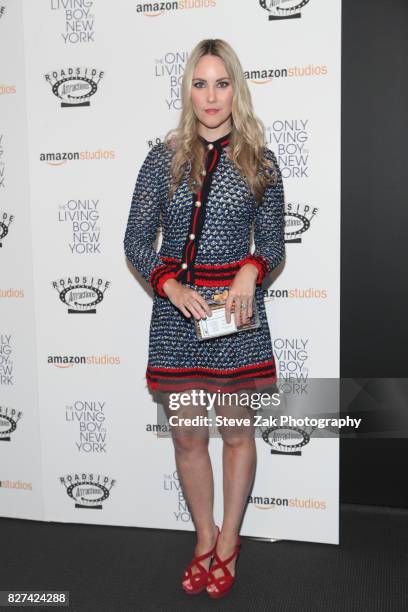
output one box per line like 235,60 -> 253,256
163,393 -> 217,588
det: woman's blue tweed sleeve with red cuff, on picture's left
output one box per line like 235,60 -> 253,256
123,145 -> 176,297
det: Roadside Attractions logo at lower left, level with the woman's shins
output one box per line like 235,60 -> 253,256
60,473 -> 116,510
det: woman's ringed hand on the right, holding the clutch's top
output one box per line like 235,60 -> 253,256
225,263 -> 258,327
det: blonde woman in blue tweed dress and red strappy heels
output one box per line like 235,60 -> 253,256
124,39 -> 284,598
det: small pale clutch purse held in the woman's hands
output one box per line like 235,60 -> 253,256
194,291 -> 261,340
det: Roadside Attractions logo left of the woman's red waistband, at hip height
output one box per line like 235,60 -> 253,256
51,276 -> 110,314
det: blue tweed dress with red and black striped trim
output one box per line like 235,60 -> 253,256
124,133 -> 285,392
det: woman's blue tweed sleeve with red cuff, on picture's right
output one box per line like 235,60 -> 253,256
240,149 -> 285,284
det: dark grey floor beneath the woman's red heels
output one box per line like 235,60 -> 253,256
0,505 -> 408,612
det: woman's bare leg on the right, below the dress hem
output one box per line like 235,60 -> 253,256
207,392 -> 256,591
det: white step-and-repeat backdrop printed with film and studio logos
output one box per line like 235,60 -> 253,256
0,0 -> 341,544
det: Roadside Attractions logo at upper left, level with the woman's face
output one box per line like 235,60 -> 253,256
44,67 -> 105,108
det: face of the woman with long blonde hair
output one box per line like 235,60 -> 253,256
191,55 -> 233,129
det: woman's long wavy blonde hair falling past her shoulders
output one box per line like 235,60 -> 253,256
165,38 -> 277,203
